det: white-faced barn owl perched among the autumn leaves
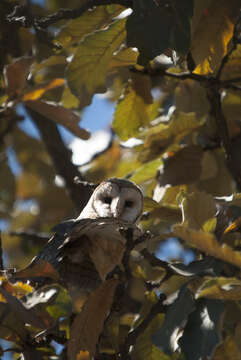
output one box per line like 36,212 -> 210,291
14,178 -> 143,308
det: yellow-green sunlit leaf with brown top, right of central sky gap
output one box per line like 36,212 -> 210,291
113,74 -> 152,140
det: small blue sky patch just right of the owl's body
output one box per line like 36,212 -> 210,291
156,238 -> 194,264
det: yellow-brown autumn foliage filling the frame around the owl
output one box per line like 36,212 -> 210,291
0,0 -> 241,360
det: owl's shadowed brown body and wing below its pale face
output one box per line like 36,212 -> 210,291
14,218 -> 142,289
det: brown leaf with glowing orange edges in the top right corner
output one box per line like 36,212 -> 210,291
191,0 -> 240,74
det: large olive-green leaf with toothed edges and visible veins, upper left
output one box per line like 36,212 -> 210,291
67,19 -> 126,97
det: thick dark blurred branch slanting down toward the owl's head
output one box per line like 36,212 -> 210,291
27,108 -> 93,213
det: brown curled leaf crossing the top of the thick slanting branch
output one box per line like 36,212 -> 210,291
25,100 -> 90,140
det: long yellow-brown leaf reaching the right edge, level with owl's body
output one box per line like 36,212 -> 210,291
173,225 -> 241,268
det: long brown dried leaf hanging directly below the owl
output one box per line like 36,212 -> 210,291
67,279 -> 119,360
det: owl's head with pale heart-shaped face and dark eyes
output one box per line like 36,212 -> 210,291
78,178 -> 143,223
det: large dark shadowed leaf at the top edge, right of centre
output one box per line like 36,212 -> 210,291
126,0 -> 193,65
